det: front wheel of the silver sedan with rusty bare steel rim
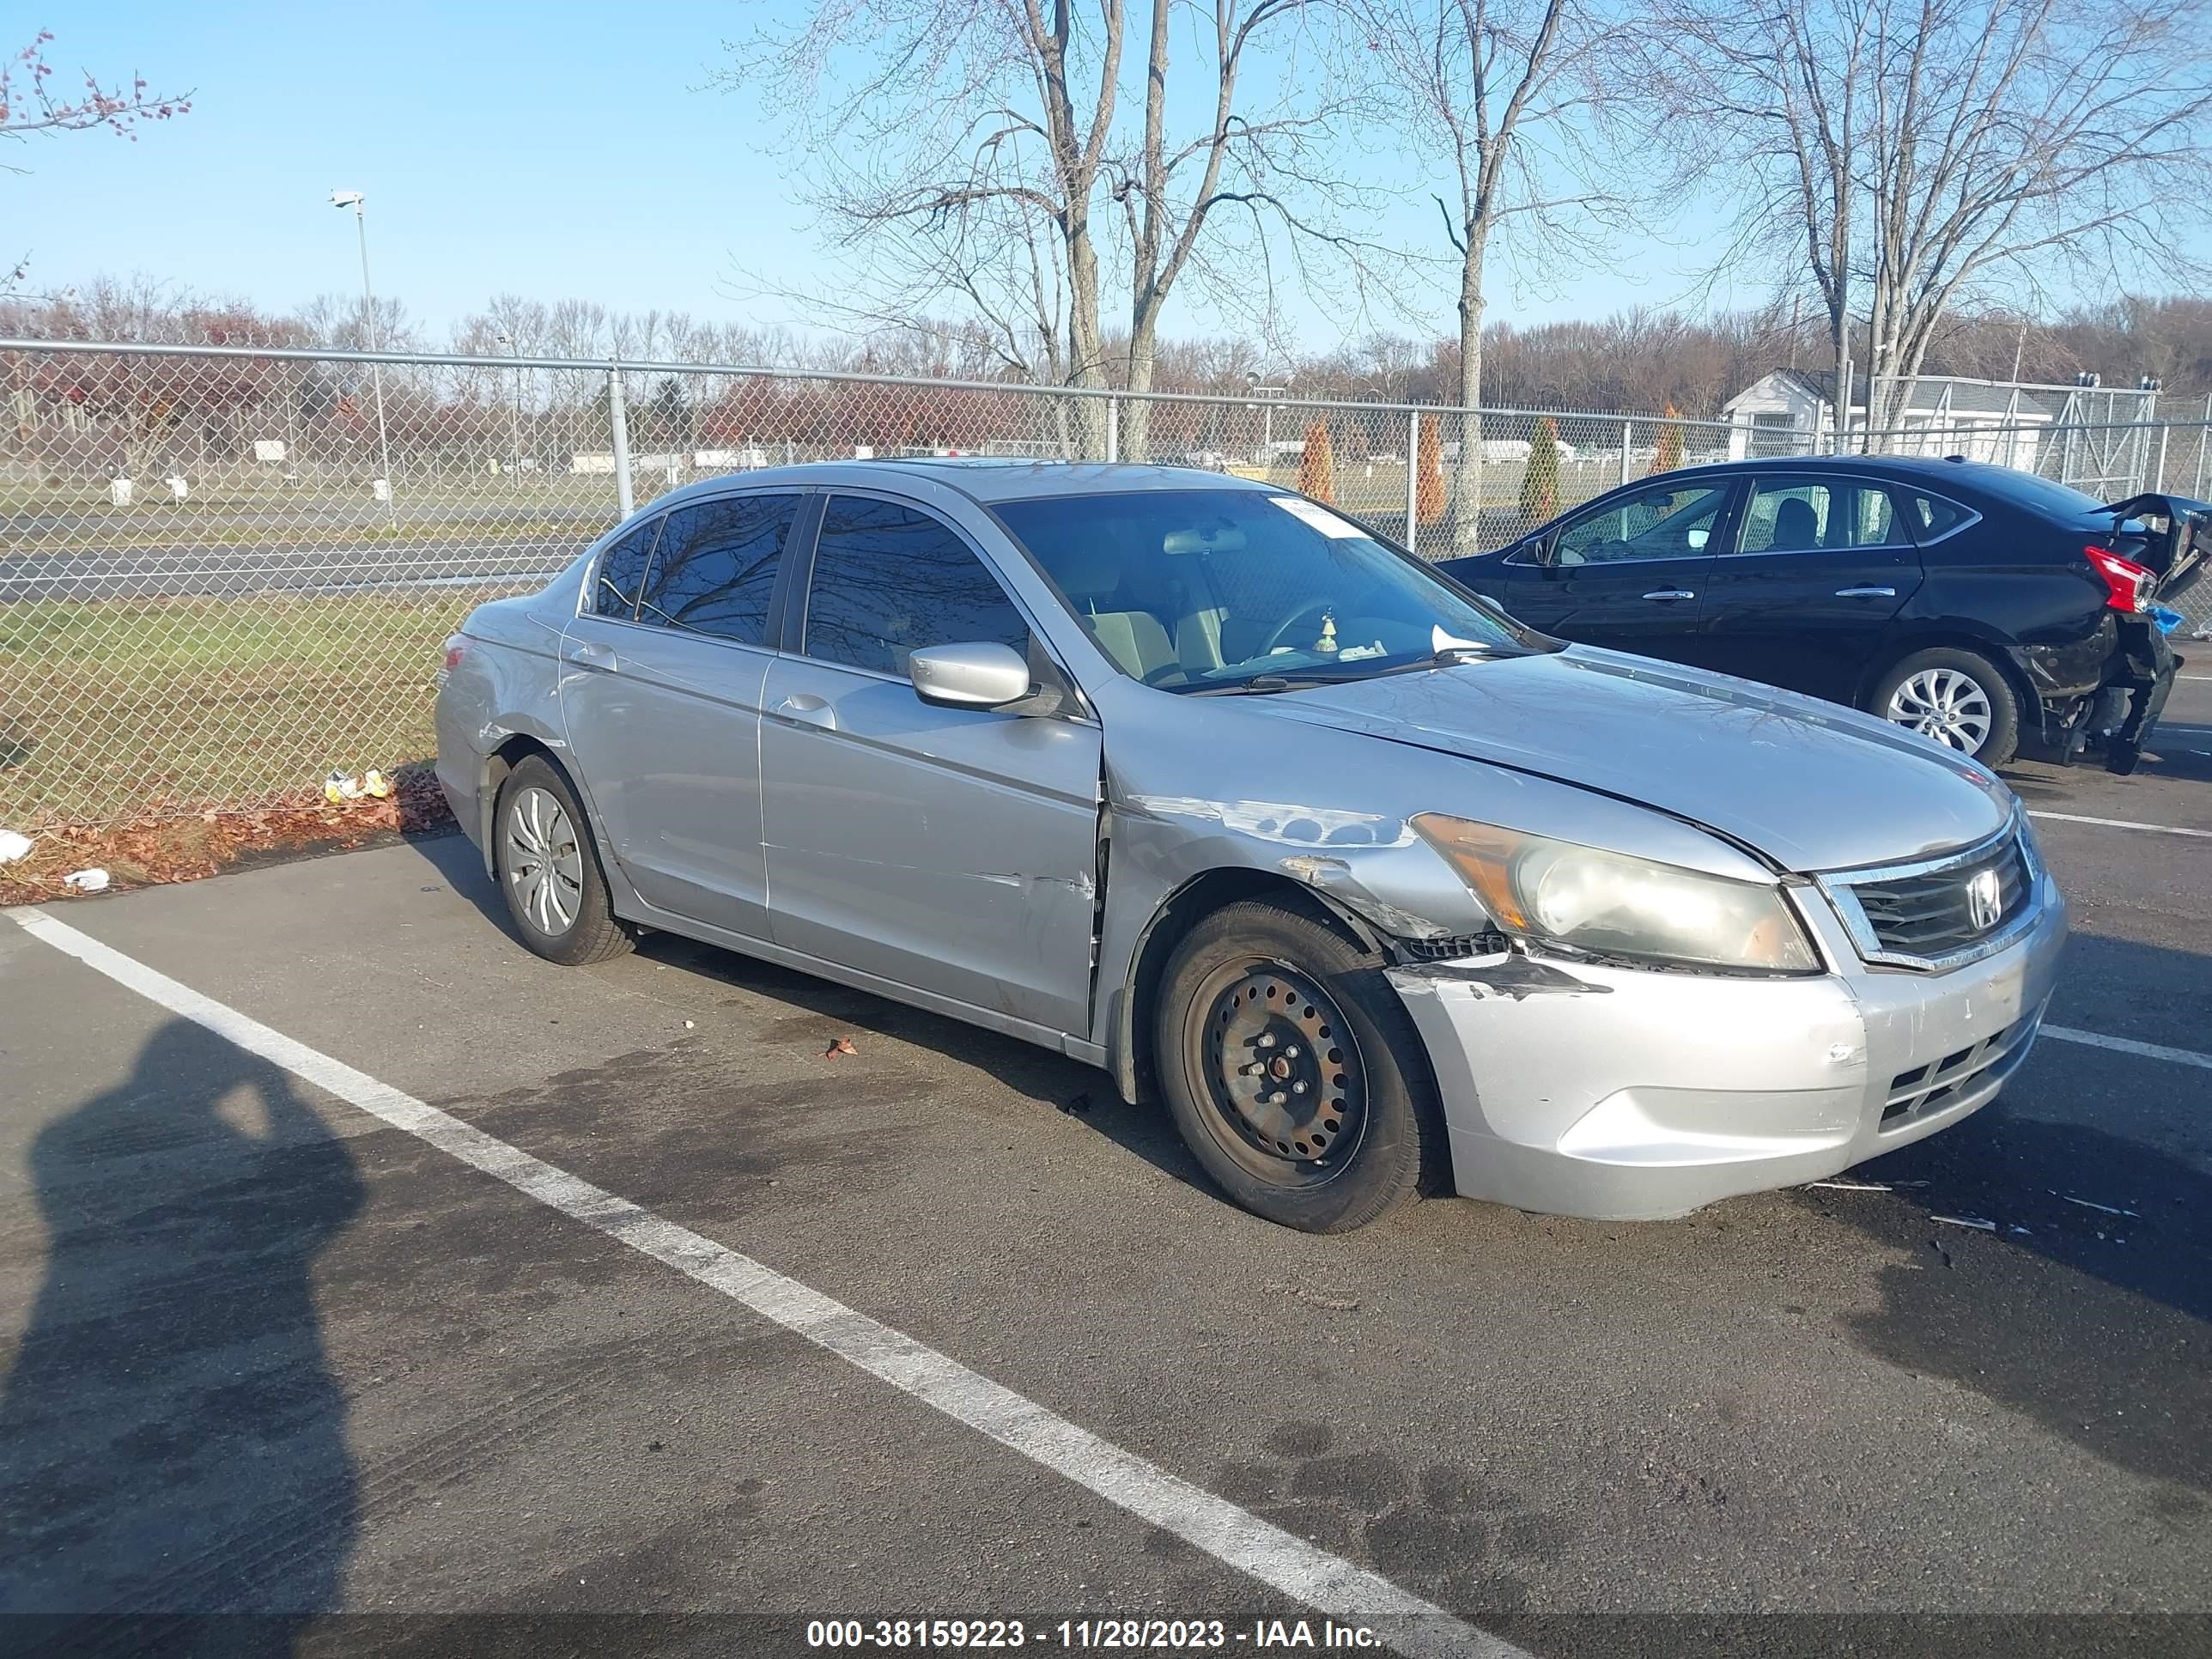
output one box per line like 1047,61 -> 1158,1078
1152,900 -> 1444,1232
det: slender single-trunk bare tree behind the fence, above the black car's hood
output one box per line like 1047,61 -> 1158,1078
1352,0 -> 1656,550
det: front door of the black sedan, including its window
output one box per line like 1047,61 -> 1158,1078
1484,477 -> 1736,661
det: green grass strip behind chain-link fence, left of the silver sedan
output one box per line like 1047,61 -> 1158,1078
0,588 -> 526,832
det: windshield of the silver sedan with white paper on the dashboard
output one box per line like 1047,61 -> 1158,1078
995,489 -> 1551,692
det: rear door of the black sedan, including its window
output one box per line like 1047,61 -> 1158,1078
1694,471 -> 1920,703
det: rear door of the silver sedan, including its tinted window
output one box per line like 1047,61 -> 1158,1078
562,491 -> 814,938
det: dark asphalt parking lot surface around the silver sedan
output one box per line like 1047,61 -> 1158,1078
0,679 -> 2212,1655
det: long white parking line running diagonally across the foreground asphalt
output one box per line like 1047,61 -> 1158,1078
7,909 -> 1528,1659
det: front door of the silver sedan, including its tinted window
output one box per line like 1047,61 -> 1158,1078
761,495 -> 1099,1033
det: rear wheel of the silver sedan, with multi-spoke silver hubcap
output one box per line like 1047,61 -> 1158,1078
491,754 -> 630,967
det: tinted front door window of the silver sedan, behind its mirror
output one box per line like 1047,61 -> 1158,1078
807,495 -> 1029,675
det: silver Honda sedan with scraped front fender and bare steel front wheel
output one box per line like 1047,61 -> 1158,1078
438,460 -> 2066,1232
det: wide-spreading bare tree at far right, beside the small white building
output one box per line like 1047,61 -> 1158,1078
1655,0 -> 2212,442
